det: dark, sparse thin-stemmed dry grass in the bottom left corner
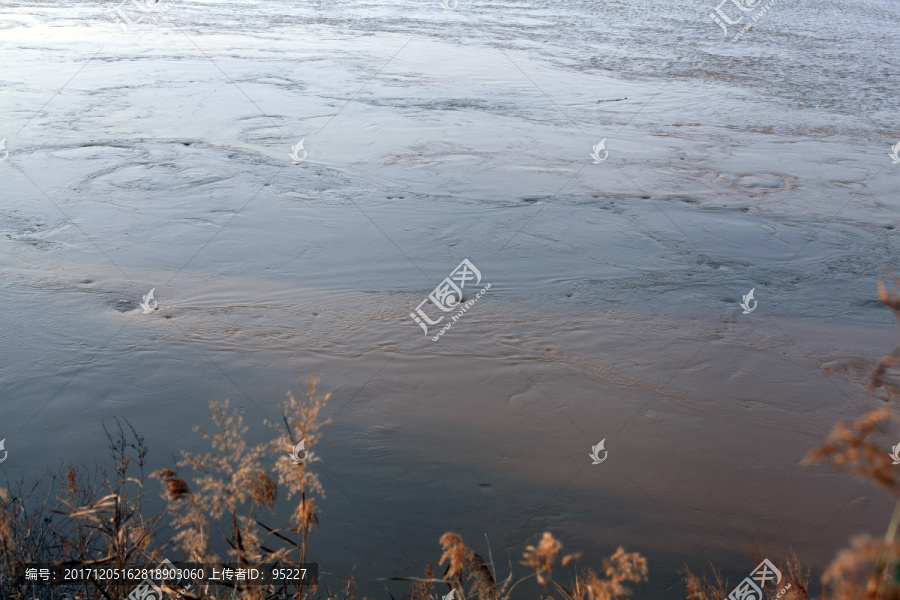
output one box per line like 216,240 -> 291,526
0,419 -> 159,600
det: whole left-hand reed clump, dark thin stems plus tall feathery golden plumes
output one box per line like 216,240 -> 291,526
0,377 -> 334,600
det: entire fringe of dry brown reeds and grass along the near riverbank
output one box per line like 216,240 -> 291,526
0,276 -> 900,600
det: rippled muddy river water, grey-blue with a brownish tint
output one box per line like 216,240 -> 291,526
0,0 -> 900,598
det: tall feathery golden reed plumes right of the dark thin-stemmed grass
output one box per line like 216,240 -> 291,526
153,375 -> 332,600
